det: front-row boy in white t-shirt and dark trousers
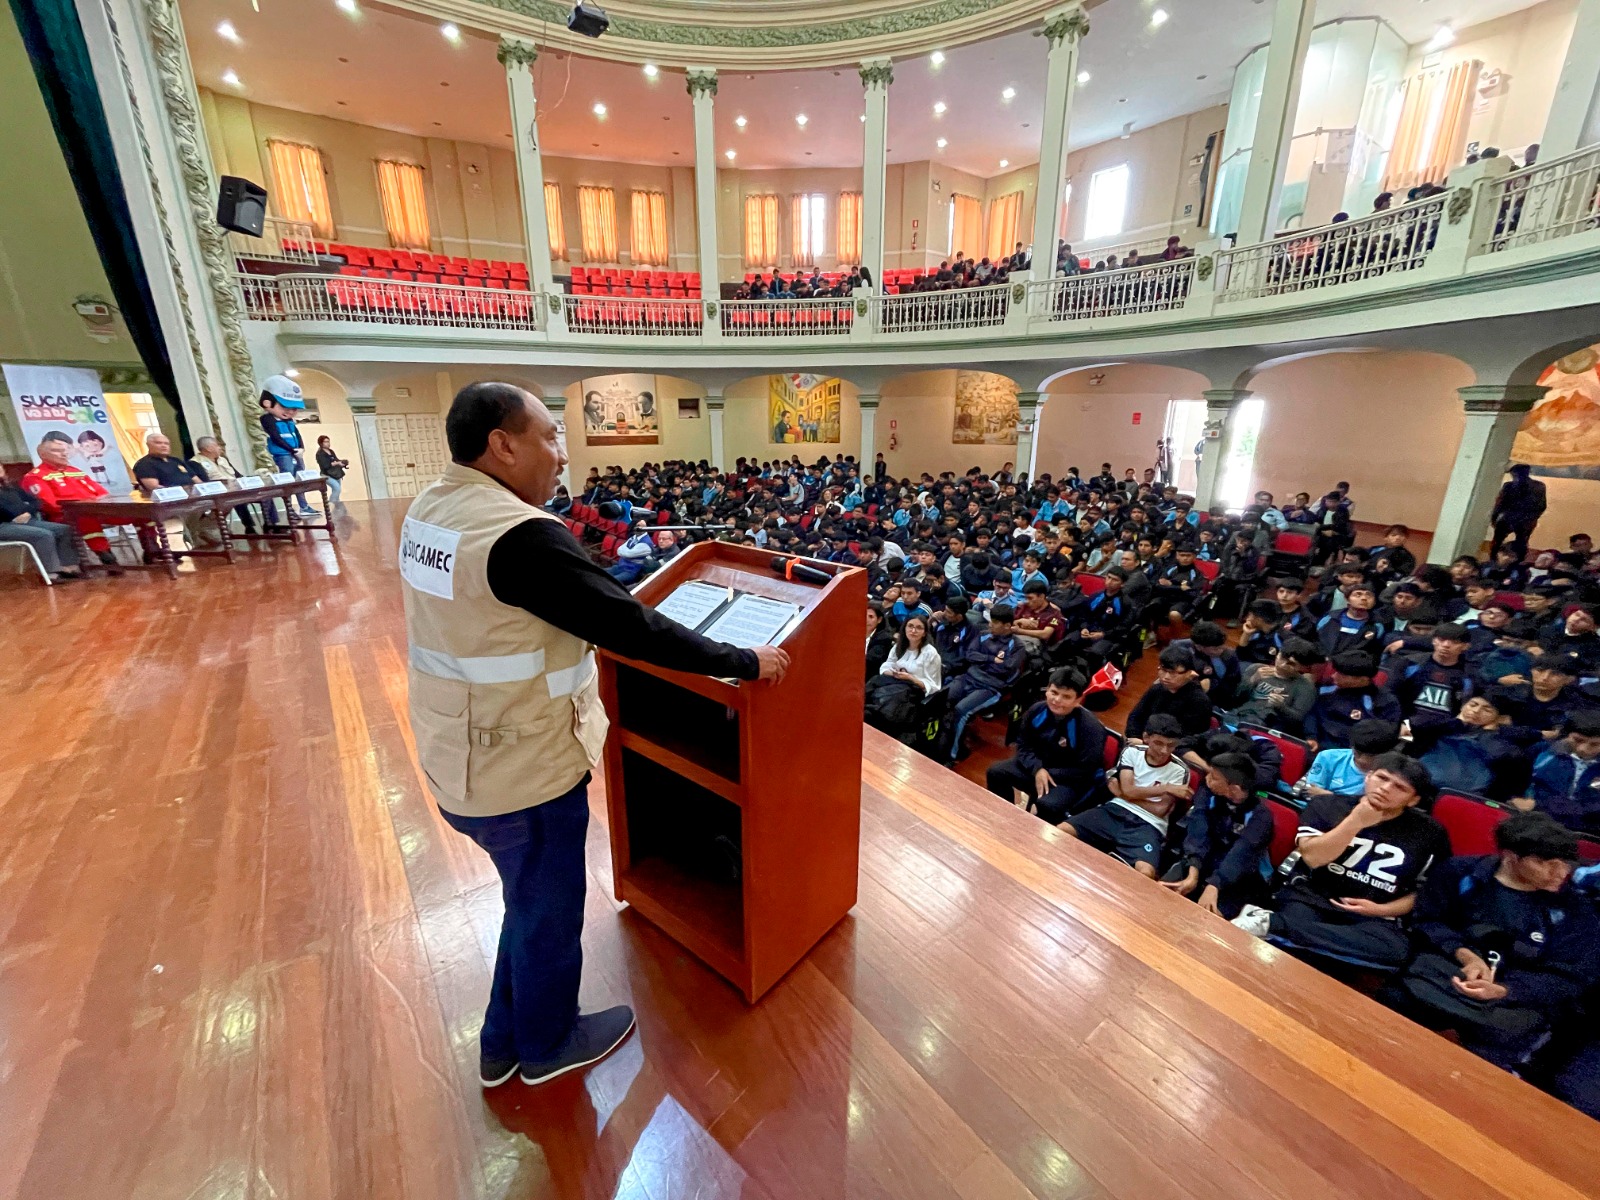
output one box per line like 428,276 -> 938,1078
1058,712 -> 1194,878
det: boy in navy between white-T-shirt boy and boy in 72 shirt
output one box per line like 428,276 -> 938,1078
1163,754 -> 1274,920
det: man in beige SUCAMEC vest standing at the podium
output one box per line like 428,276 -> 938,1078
400,382 -> 789,1088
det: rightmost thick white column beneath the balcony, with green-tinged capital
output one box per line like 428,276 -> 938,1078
1427,384 -> 1547,565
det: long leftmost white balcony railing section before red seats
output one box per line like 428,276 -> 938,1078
238,274 -> 544,333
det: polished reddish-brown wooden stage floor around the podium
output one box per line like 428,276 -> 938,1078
0,504 -> 1600,1200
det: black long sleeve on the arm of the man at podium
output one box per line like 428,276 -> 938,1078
488,517 -> 760,678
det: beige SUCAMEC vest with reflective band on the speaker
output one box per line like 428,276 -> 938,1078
400,462 -> 606,816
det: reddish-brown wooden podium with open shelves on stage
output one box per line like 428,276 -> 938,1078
600,542 -> 867,1003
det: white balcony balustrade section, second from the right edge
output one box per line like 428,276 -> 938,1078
1218,195 -> 1446,301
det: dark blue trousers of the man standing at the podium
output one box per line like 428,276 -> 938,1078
443,776 -> 589,1062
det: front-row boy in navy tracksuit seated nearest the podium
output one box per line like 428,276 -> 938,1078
987,667 -> 1106,826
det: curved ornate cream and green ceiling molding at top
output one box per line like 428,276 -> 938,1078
384,0 -> 1096,69
